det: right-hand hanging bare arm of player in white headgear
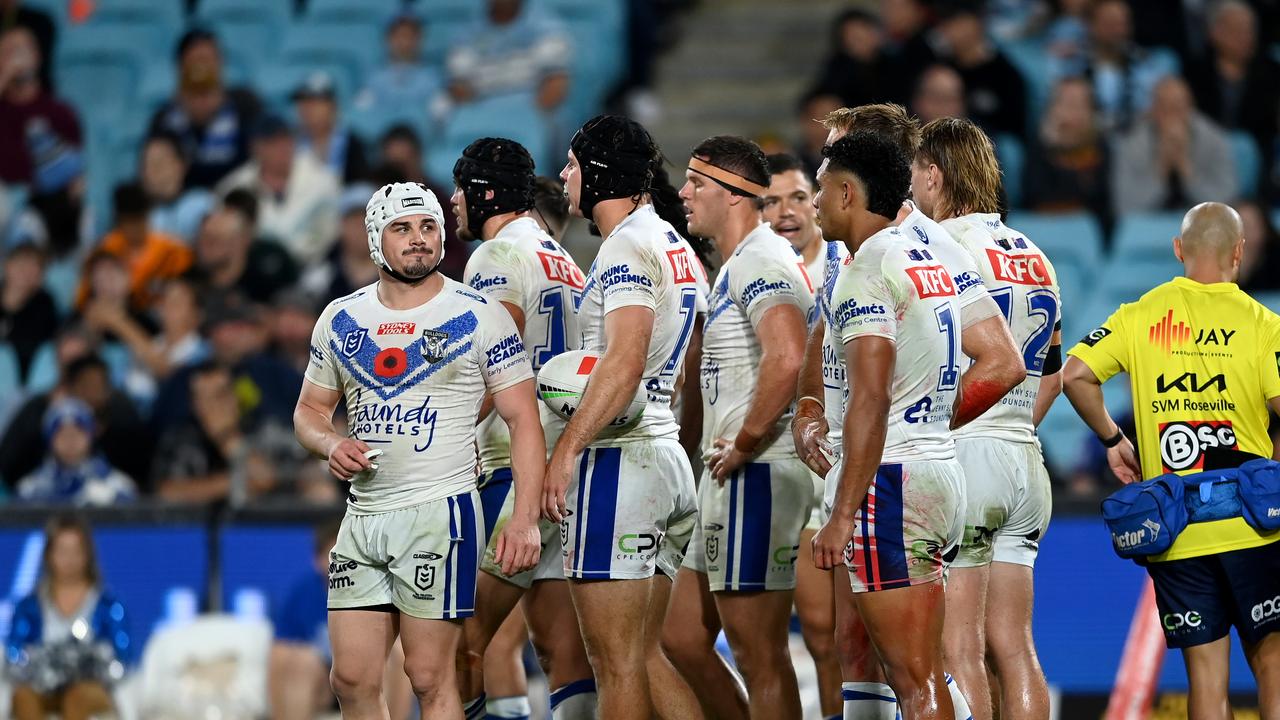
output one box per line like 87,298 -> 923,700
492,379 -> 547,575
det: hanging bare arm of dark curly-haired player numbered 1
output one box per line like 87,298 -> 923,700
813,336 -> 897,570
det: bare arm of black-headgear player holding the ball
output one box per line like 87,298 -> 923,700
543,305 -> 654,523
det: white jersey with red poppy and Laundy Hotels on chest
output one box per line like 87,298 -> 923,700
306,278 -> 534,515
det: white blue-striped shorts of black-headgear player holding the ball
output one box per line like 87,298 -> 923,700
561,439 -> 698,580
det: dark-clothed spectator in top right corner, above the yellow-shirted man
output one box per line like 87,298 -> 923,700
1185,0 -> 1280,169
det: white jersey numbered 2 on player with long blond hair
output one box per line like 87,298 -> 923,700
942,213 -> 1062,442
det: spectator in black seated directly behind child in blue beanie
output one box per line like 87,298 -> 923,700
0,351 -> 151,486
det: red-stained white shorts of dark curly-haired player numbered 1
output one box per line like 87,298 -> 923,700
831,460 -> 965,592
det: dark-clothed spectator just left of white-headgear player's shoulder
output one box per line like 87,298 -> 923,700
151,295 -> 302,430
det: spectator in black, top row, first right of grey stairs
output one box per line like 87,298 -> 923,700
814,8 -> 888,108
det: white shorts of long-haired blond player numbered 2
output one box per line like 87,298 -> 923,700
954,437 -> 1053,568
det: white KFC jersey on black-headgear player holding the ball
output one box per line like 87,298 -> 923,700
579,205 -> 707,447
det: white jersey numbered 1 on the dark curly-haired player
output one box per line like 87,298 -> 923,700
829,227 -> 961,462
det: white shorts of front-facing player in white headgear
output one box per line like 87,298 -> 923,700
329,491 -> 484,620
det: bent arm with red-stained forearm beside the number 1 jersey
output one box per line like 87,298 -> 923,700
951,315 -> 1027,430
